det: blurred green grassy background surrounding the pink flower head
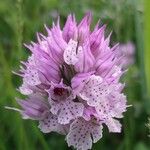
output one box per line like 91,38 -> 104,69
0,0 -> 150,150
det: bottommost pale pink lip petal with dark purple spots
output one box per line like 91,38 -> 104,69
67,119 -> 102,150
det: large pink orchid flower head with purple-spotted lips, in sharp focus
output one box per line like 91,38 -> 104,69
10,13 -> 127,150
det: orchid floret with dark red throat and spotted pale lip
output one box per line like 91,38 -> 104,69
48,82 -> 84,124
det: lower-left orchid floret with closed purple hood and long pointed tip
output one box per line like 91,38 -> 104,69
7,94 -> 69,135
